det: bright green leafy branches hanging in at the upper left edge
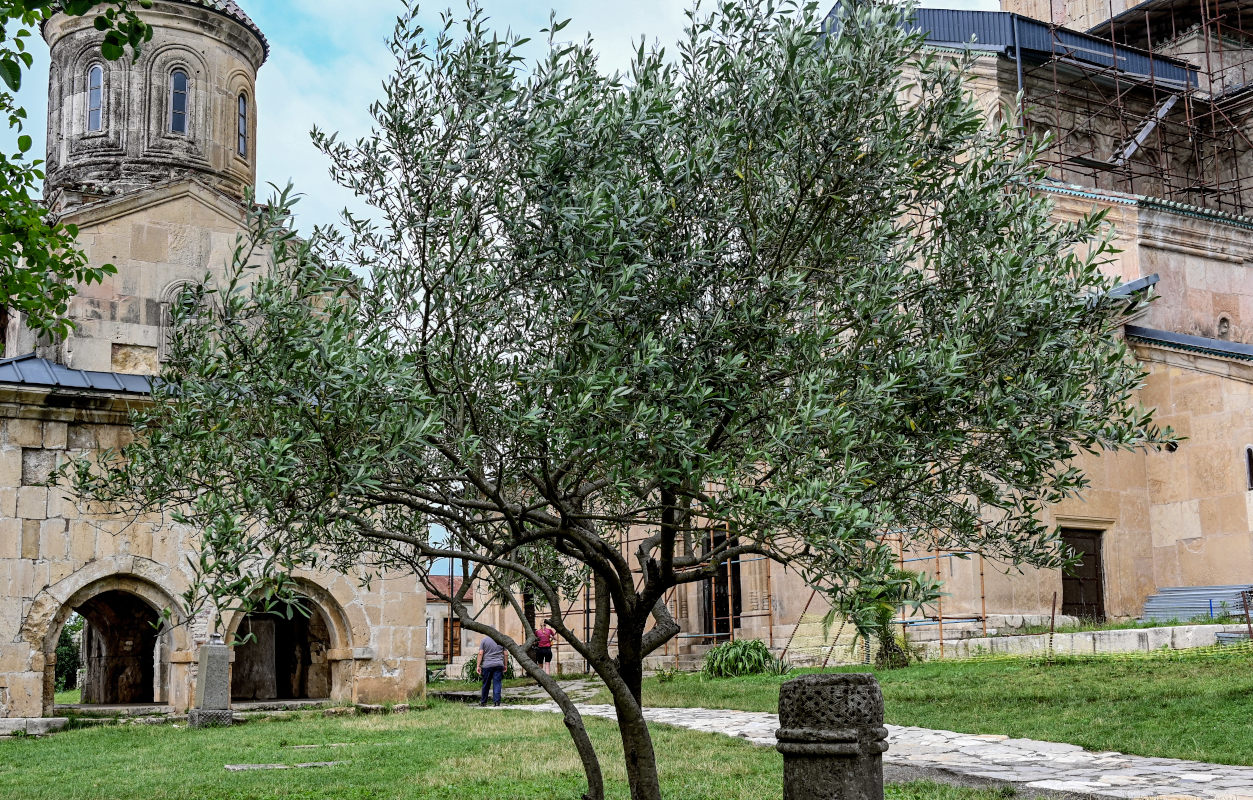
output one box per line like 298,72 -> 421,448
0,0 -> 152,336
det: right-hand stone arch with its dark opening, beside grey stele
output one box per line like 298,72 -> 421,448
226,578 -> 353,701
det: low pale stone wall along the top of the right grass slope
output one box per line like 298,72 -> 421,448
916,624 -> 1247,660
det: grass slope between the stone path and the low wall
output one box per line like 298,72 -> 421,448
591,651 -> 1253,765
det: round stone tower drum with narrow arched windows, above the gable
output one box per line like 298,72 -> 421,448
43,0 -> 268,213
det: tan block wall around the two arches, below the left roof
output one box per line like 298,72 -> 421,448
0,391 -> 426,717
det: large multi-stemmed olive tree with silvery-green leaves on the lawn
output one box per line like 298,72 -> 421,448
68,0 -> 1160,800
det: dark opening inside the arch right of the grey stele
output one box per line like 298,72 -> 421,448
231,608 -> 331,701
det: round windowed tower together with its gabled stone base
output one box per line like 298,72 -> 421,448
4,0 -> 268,375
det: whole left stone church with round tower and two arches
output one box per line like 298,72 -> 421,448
0,0 -> 426,718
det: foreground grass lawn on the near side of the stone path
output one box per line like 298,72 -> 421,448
0,703 -> 1005,800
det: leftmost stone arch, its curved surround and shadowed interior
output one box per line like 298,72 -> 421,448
23,559 -> 190,715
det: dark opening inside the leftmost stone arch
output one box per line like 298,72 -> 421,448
74,591 -> 162,705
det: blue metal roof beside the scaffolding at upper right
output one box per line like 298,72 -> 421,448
910,9 -> 1197,88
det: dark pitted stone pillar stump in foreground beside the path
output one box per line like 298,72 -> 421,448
776,673 -> 887,800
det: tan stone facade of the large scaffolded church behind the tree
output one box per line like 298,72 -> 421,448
473,0 -> 1253,666
